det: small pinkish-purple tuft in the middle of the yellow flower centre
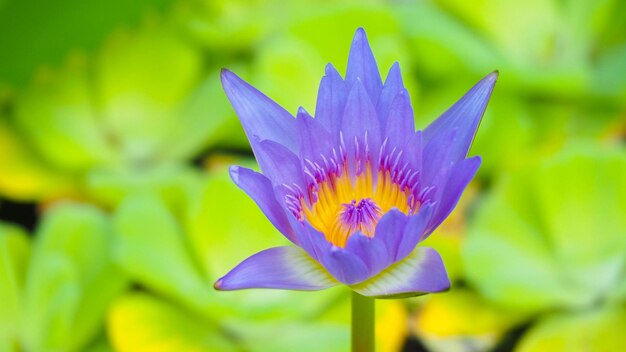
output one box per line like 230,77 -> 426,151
338,198 -> 382,237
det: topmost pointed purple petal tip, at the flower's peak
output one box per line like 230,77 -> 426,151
346,28 -> 383,103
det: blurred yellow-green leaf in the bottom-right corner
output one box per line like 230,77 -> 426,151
515,305 -> 626,352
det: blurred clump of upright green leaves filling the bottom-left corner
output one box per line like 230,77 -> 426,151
0,203 -> 128,351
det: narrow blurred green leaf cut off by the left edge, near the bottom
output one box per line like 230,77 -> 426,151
0,224 -> 30,347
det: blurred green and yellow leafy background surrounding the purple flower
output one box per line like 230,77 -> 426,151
0,0 -> 626,352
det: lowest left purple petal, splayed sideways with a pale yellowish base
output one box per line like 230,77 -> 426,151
214,246 -> 337,291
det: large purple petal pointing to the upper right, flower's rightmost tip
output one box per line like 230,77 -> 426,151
424,71 -> 498,165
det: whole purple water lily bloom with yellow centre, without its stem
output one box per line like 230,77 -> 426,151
215,29 -> 497,297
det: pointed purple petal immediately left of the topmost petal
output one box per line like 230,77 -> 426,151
315,64 -> 349,131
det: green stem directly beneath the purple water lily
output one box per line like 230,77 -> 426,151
352,291 -> 375,352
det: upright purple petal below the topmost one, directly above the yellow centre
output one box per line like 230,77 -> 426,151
341,80 -> 381,174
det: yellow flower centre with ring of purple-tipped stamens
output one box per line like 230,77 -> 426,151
283,134 -> 422,247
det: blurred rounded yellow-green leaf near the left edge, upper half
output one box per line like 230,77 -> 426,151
13,57 -> 113,172
